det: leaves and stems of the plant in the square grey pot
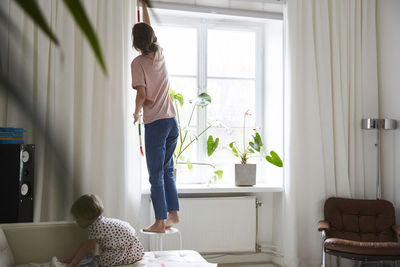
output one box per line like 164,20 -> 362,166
229,110 -> 283,167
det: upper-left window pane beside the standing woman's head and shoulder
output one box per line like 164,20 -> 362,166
154,26 -> 197,75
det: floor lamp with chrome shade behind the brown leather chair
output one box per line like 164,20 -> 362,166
361,118 -> 397,199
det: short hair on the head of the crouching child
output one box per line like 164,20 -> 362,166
71,194 -> 104,221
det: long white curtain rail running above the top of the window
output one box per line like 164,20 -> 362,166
152,1 -> 283,20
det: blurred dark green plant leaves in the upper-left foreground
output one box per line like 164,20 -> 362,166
0,0 -> 126,201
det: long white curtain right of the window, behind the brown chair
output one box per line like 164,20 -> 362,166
284,0 -> 378,266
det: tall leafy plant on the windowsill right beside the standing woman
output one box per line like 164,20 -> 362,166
169,89 -> 223,182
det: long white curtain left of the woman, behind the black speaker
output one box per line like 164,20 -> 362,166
0,0 -> 141,230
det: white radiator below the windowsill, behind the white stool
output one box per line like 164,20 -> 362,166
150,196 -> 256,253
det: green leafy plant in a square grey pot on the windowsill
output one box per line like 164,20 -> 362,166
229,110 -> 283,186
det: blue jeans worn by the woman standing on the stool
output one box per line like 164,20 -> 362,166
144,117 -> 179,220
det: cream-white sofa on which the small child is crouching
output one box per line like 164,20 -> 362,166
0,222 -> 217,267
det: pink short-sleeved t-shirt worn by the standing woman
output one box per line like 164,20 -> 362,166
131,55 -> 176,124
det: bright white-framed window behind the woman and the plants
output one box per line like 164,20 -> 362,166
144,10 -> 283,186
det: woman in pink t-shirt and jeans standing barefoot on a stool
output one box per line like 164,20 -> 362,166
131,1 -> 179,233
